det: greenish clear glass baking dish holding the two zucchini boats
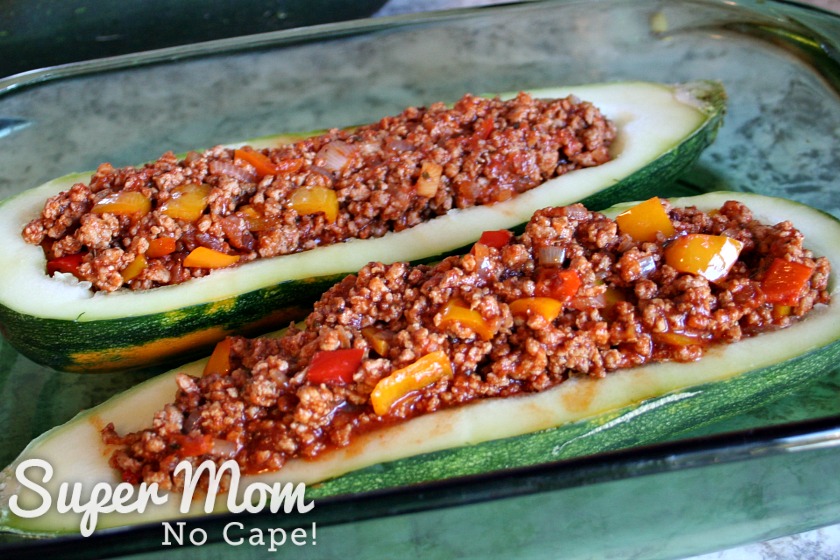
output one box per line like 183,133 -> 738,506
0,0 -> 840,560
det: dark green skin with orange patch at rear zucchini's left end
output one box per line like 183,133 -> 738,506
0,272 -> 349,373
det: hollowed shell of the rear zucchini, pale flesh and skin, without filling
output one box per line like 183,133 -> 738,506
0,82 -> 726,371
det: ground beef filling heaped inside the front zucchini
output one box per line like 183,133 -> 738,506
103,202 -> 830,489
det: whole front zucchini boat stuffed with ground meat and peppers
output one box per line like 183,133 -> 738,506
0,192 -> 840,534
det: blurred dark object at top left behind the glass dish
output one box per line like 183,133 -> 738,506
0,0 -> 840,77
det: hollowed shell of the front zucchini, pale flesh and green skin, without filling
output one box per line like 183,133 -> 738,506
0,192 -> 840,535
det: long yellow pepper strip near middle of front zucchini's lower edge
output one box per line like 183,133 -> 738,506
370,350 -> 452,416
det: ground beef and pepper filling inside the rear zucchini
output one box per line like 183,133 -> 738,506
18,94 -> 615,291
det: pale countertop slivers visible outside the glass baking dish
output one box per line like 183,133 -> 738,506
376,0 -> 840,560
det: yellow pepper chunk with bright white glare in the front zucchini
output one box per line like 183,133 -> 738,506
665,233 -> 744,282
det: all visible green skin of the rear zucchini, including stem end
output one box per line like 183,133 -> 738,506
0,82 -> 726,372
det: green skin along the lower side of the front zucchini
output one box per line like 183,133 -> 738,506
309,341 -> 840,498
